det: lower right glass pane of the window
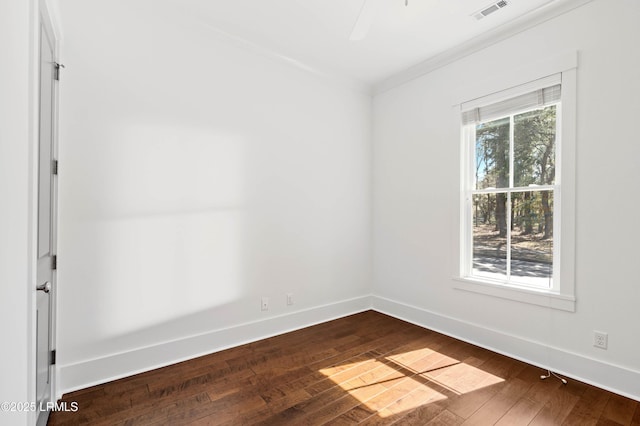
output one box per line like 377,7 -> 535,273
511,191 -> 553,287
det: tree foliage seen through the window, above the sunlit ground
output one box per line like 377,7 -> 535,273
474,106 -> 556,238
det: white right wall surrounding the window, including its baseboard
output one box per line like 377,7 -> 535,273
373,0 -> 640,398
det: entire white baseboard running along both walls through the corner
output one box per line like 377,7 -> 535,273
56,296 -> 640,401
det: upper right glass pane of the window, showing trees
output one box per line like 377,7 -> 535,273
513,105 -> 556,186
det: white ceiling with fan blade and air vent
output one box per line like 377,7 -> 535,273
171,0 -> 566,85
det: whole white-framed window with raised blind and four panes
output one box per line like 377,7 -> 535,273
458,68 -> 574,310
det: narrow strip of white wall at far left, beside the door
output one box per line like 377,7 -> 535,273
0,0 -> 37,425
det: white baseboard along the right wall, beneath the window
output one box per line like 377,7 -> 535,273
372,296 -> 640,401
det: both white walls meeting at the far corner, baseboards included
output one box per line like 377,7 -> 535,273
53,0 -> 640,398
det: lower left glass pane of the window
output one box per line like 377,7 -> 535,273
472,194 -> 507,280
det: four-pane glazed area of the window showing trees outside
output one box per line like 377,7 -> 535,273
469,104 -> 557,288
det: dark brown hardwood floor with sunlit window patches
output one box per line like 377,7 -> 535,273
49,311 -> 640,426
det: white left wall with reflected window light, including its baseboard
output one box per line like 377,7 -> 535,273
58,0 -> 371,392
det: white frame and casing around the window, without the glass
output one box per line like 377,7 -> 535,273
453,52 -> 577,312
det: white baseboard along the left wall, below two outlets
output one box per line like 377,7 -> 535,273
55,296 -> 371,399
